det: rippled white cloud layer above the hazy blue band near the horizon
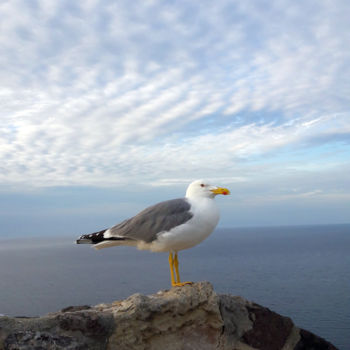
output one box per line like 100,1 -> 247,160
0,1 -> 350,193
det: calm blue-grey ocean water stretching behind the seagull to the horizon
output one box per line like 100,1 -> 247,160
0,225 -> 350,350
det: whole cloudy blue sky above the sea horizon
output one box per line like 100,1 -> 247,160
0,0 -> 350,237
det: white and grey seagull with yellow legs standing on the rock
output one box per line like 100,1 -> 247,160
76,180 -> 230,287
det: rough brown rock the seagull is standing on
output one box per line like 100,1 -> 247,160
0,282 -> 336,350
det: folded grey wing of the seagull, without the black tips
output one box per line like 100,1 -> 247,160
109,198 -> 193,243
